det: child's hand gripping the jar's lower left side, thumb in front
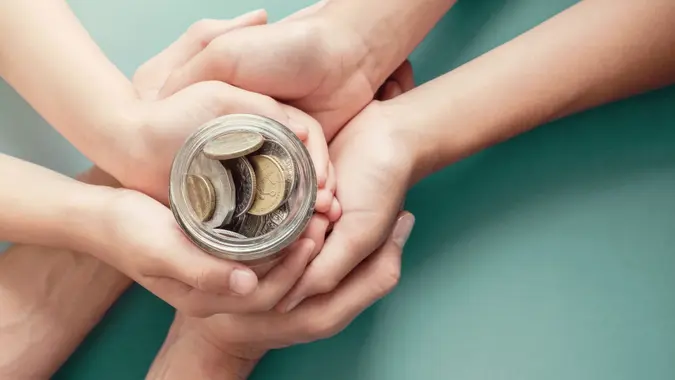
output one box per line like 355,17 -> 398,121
78,167 -> 315,317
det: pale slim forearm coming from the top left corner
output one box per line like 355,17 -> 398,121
0,0 -> 136,168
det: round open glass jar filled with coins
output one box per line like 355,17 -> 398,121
169,114 -> 317,265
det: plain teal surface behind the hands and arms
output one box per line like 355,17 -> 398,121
0,0 -> 675,380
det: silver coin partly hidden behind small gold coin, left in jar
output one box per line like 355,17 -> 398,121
188,154 -> 236,228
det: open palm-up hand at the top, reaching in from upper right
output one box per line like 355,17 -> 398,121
155,1 -> 394,141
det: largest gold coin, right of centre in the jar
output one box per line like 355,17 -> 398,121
248,155 -> 286,215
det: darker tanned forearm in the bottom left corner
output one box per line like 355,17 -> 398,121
0,246 -> 130,380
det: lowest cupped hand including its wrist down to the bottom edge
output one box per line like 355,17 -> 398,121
147,212 -> 412,379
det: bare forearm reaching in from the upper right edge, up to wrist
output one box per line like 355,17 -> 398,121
386,0 -> 675,178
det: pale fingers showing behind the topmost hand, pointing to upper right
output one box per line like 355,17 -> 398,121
133,9 -> 267,99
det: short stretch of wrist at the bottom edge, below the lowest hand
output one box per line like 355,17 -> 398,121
146,316 -> 256,380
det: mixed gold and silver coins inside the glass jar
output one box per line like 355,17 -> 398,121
185,132 -> 295,238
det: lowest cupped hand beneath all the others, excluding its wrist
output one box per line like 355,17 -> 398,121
158,212 -> 413,361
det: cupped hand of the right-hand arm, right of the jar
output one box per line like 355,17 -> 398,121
278,69 -> 416,311
